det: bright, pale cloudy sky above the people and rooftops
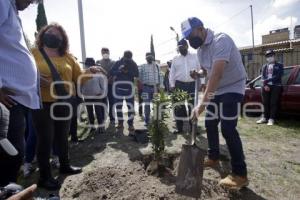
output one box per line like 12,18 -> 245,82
20,0 -> 300,64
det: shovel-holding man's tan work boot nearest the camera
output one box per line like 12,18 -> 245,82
219,175 -> 249,190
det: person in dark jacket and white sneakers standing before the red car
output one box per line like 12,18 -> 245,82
256,50 -> 283,126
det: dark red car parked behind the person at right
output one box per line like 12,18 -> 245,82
244,65 -> 300,115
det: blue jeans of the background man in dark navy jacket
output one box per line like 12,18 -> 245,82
115,88 -> 134,126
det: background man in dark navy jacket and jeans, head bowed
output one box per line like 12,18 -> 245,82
110,51 -> 139,133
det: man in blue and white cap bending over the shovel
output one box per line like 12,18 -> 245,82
181,17 -> 249,189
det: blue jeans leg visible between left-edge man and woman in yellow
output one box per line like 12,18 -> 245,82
25,111 -> 36,163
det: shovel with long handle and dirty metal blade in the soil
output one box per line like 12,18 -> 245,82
175,78 -> 206,198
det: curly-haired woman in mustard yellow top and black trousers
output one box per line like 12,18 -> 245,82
32,24 -> 101,190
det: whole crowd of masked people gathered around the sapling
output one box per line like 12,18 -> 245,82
0,0 -> 282,198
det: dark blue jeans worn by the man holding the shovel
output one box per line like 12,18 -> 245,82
205,93 -> 247,176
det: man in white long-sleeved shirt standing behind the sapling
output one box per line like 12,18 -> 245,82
169,40 -> 201,134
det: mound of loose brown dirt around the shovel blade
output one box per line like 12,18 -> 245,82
60,148 -> 239,200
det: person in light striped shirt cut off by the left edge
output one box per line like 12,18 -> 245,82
0,0 -> 40,186
